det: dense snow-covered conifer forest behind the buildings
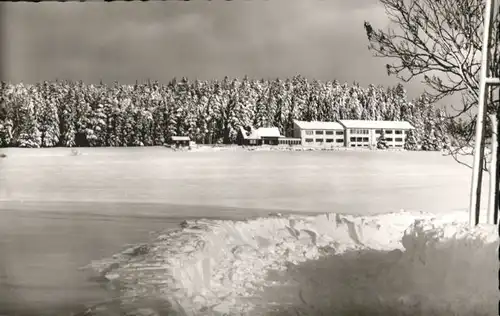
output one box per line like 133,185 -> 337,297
0,76 -> 451,150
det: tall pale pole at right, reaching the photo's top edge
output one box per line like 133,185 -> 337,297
469,0 -> 493,226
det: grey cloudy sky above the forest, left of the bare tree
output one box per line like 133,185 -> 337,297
1,0 -> 446,101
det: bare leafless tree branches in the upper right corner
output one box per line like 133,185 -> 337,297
364,0 -> 500,166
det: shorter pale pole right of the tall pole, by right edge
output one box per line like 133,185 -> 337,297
486,114 -> 498,224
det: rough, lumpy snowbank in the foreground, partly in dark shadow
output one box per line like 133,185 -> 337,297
87,212 -> 498,315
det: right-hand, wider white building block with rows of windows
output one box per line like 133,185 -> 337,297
339,120 -> 414,148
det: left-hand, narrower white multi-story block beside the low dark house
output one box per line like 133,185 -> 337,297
293,120 -> 345,147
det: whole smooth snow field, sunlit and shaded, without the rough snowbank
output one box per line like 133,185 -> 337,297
0,148 -> 492,315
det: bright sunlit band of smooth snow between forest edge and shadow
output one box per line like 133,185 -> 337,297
0,148 -> 480,216
